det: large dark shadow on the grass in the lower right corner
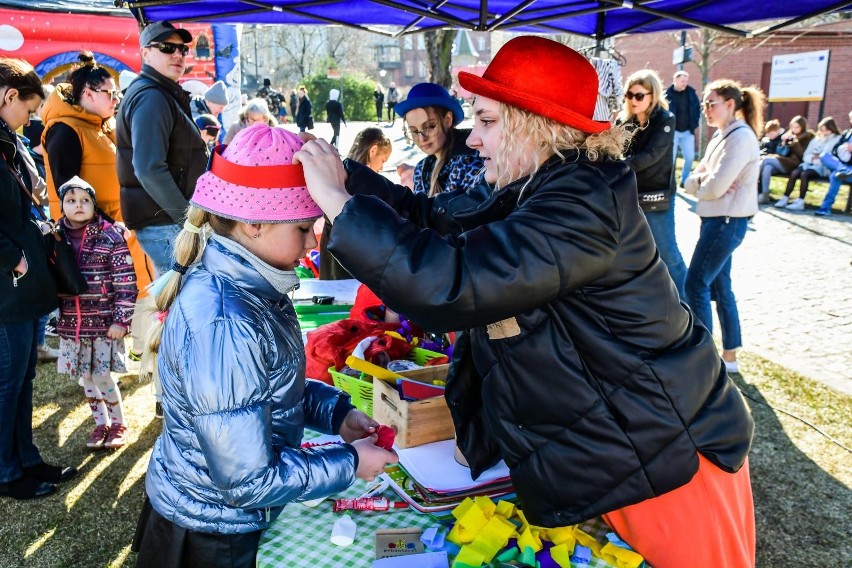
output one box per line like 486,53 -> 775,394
733,374 -> 852,568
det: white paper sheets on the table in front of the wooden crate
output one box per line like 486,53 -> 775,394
396,440 -> 509,493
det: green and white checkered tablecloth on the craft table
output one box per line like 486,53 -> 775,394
257,480 -> 624,568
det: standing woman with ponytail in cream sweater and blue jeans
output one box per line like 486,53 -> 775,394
684,79 -> 764,373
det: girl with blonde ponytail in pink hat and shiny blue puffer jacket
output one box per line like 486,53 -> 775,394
133,124 -> 397,568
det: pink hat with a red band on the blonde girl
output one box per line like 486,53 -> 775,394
190,124 -> 322,223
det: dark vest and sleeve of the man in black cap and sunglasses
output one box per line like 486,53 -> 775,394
116,65 -> 208,229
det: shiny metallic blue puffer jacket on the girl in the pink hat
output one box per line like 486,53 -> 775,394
145,240 -> 357,534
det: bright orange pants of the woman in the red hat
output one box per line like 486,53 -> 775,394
603,454 -> 755,568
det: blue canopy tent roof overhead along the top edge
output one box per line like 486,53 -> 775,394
116,0 -> 852,37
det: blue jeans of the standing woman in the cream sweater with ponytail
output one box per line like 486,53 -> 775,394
686,217 -> 748,349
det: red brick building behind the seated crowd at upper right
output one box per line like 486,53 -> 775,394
615,20 -> 852,129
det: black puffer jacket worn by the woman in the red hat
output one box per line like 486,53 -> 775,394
329,155 -> 754,527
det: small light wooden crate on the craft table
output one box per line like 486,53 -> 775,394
373,365 -> 455,448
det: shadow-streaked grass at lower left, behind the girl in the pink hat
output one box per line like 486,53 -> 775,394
0,365 -> 161,568
